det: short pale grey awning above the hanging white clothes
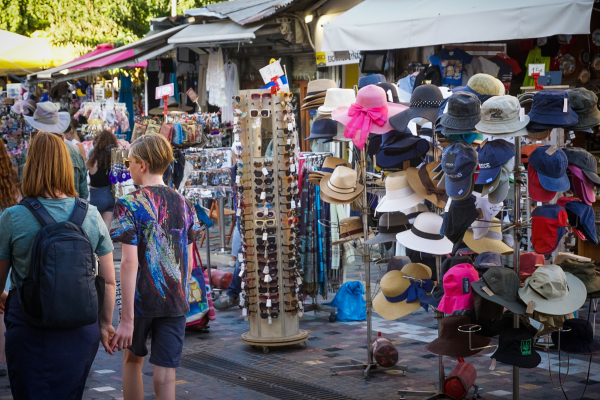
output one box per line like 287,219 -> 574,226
169,21 -> 262,47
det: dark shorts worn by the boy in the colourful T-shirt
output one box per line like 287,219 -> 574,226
128,315 -> 185,368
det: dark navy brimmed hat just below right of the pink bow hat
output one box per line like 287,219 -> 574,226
377,131 -> 430,168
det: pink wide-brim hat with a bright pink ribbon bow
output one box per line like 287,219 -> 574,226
331,85 -> 408,150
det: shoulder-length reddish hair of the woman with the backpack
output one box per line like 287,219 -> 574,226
22,131 -> 77,199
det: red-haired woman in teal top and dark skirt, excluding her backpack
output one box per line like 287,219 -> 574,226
0,131 -> 116,400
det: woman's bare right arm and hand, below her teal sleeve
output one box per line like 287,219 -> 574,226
97,252 -> 117,356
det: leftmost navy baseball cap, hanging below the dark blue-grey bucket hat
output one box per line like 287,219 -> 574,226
441,142 -> 477,200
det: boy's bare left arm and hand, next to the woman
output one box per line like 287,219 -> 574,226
110,243 -> 138,350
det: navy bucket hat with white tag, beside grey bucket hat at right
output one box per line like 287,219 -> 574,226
527,90 -> 579,127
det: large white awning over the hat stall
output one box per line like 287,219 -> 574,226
321,0 -> 594,51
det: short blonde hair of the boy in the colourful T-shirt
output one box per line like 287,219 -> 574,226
129,134 -> 173,175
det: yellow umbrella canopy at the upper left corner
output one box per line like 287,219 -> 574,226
0,31 -> 77,75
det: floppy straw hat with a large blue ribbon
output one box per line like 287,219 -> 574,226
373,263 -> 433,321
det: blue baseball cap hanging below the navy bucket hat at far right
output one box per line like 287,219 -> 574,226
529,145 -> 571,192
